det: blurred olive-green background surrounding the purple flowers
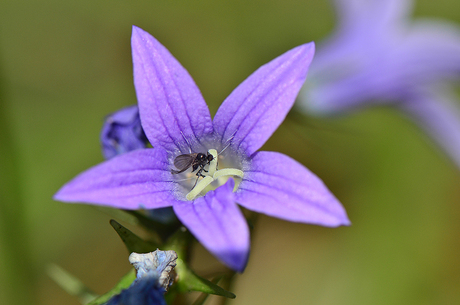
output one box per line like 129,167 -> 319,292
0,0 -> 460,305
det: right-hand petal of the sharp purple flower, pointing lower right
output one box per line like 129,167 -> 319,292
236,151 -> 350,227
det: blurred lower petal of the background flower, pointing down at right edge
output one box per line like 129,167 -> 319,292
400,92 -> 460,167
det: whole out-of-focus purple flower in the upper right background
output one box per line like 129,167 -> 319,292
298,0 -> 460,166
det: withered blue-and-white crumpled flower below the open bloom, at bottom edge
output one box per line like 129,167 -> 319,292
105,250 -> 177,305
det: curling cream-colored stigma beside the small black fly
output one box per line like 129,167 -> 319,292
185,149 -> 244,201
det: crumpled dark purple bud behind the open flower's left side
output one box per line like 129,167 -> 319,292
101,105 -> 147,159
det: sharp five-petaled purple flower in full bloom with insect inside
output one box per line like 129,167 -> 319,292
55,27 -> 350,272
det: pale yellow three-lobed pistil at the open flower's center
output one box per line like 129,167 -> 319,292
185,149 -> 244,200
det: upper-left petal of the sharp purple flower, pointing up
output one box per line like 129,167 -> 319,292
131,26 -> 213,151
